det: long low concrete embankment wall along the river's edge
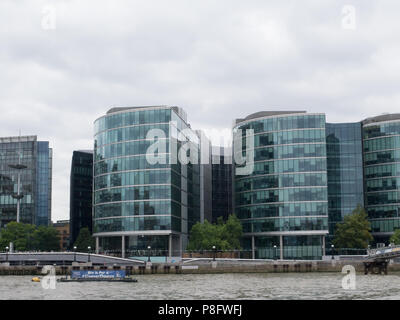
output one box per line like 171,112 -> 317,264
0,260 -> 400,275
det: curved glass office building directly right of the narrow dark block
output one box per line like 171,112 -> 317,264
93,106 -> 200,256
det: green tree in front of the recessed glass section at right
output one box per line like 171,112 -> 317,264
333,205 -> 373,249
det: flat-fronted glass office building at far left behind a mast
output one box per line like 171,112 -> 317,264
0,136 -> 52,228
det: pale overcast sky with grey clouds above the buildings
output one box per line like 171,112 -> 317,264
0,0 -> 400,221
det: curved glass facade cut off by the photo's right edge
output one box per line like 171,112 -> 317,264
363,117 -> 400,242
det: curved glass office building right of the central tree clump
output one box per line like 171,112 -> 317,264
233,111 -> 328,259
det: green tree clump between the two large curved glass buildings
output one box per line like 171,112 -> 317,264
187,215 -> 242,251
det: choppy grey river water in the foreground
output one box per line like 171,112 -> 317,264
0,273 -> 400,300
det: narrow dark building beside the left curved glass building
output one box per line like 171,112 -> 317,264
69,150 -> 93,245
